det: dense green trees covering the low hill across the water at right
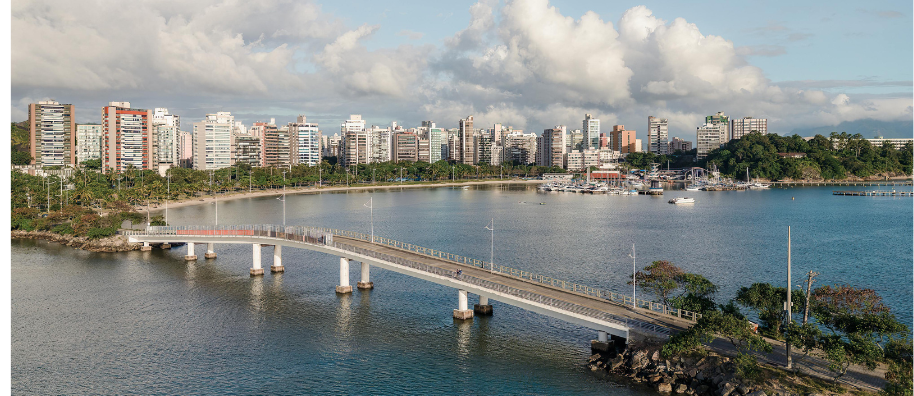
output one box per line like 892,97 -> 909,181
705,132 -> 912,180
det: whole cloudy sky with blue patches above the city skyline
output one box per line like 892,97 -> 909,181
11,0 -> 914,140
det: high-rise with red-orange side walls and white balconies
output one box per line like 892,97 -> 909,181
102,102 -> 155,172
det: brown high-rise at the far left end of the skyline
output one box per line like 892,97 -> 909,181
29,100 -> 76,166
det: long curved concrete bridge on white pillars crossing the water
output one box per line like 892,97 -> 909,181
122,225 -> 699,350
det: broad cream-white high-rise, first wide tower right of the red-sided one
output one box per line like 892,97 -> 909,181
193,111 -> 235,170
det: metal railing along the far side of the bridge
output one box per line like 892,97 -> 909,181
121,224 -> 701,322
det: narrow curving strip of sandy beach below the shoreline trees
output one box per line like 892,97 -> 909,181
135,179 -> 545,213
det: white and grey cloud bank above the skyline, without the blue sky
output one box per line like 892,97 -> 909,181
12,0 -> 911,138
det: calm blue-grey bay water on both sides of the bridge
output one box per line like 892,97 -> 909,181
12,185 -> 914,395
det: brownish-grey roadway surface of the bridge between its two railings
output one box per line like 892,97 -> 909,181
334,236 -> 691,332
